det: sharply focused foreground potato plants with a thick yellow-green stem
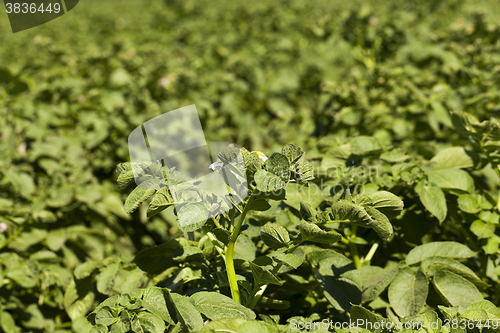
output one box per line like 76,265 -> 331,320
89,130 -> 500,332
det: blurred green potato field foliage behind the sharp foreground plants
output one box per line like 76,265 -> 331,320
0,0 -> 500,332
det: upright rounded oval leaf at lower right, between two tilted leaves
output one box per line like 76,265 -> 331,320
389,267 -> 429,317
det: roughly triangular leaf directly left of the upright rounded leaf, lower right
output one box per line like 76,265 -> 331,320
358,265 -> 399,303
